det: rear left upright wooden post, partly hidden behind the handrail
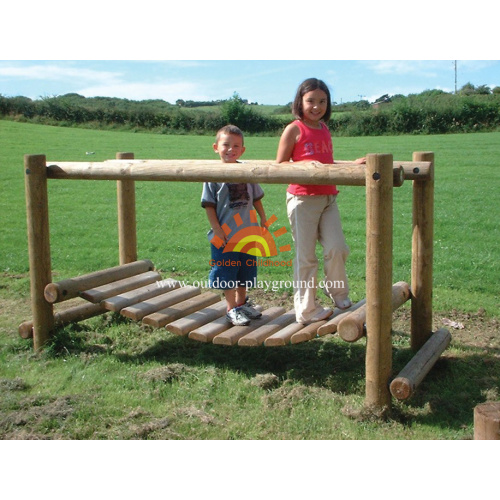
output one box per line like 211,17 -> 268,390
116,153 -> 137,265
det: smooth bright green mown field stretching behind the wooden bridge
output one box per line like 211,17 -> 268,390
0,121 -> 500,314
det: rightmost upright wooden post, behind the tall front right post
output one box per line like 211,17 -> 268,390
411,152 -> 434,351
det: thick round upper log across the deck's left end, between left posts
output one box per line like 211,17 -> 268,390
44,260 -> 154,304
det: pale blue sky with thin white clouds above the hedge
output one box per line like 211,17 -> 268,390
0,60 -> 500,105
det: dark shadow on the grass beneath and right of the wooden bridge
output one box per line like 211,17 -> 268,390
48,319 -> 500,430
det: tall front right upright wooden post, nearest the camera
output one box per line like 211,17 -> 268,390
365,154 -> 393,410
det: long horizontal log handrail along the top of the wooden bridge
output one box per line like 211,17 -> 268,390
43,160 -> 428,186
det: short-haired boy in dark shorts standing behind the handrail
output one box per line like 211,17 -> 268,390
201,125 -> 266,326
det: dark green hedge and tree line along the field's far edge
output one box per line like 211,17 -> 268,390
0,83 -> 500,136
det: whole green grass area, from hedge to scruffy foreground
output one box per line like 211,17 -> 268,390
0,121 -> 500,440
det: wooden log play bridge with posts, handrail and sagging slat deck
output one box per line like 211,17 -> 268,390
19,152 -> 451,408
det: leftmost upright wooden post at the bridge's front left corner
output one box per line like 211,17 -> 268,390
24,155 -> 54,350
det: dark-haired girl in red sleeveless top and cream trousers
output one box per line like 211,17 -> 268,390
276,78 -> 365,323
